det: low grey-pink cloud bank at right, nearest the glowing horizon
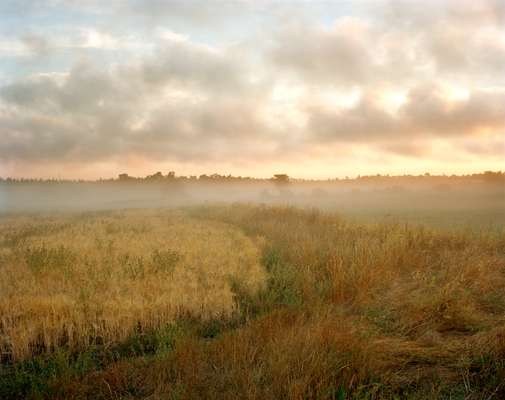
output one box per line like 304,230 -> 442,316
307,85 -> 505,145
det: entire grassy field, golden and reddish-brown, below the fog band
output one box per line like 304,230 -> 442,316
0,205 -> 505,400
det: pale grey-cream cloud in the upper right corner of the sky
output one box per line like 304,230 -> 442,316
271,2 -> 505,87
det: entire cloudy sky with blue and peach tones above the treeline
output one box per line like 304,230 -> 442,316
0,0 -> 505,179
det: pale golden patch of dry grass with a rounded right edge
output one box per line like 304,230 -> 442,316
0,211 -> 265,360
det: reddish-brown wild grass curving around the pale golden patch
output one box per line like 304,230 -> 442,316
0,205 -> 505,400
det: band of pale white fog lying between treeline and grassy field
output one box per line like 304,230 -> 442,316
0,174 -> 505,228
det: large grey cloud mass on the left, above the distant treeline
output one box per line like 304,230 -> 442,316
0,35 -> 280,161
